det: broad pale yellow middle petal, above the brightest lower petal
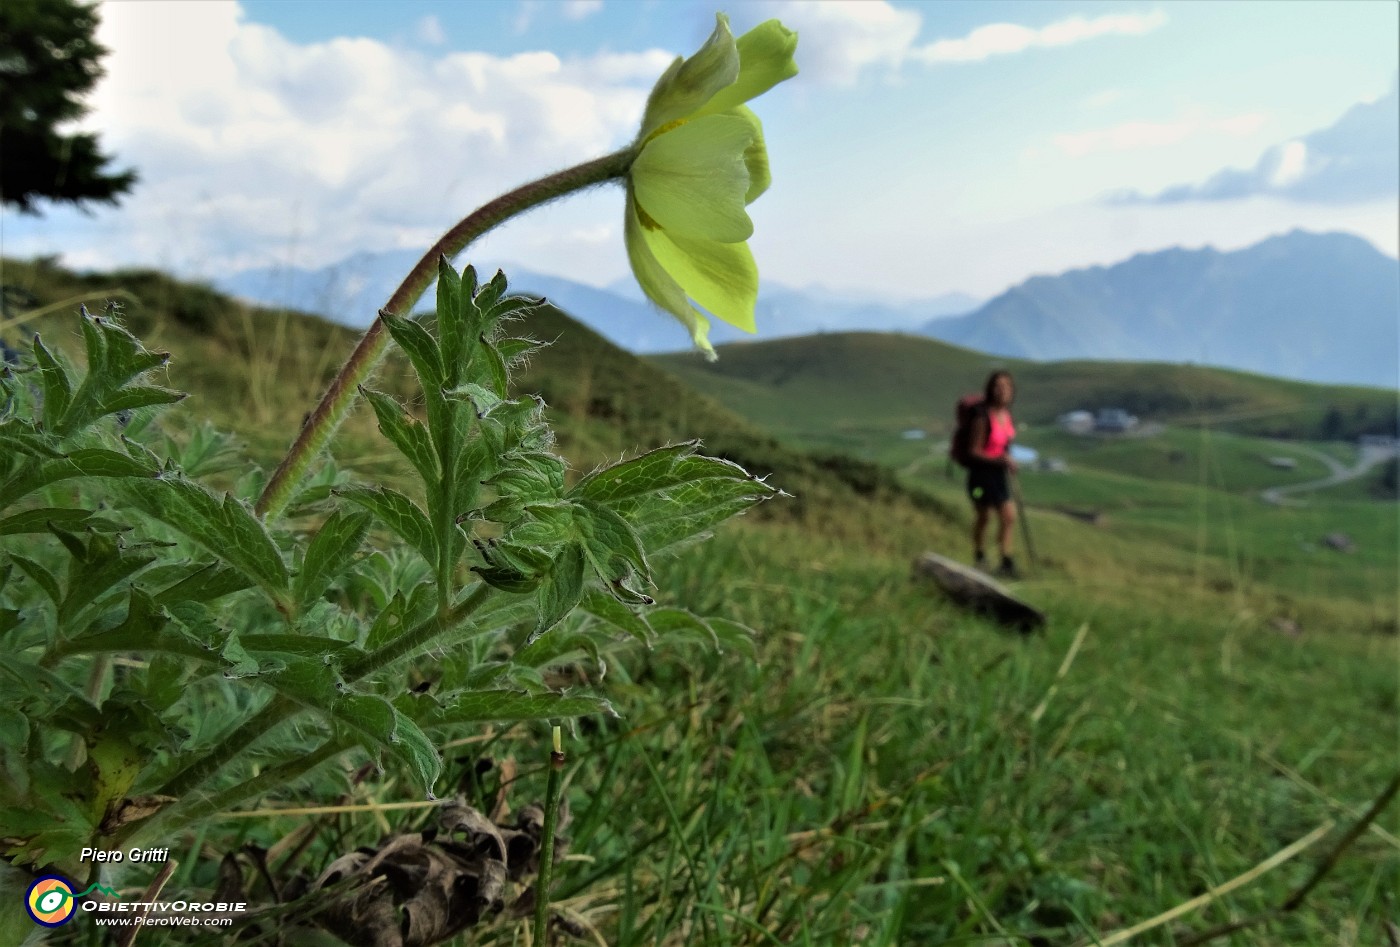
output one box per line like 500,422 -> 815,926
631,113 -> 755,244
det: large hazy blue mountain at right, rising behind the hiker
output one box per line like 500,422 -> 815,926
923,230 -> 1400,388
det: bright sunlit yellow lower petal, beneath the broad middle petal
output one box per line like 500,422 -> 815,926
633,227 -> 759,332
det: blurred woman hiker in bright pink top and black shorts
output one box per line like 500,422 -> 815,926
967,371 -> 1019,579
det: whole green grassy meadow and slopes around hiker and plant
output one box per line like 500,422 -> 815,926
4,254 -> 1400,947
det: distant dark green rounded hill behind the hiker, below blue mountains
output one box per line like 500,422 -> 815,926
654,333 -> 1396,448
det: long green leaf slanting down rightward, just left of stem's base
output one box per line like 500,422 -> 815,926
123,478 -> 290,602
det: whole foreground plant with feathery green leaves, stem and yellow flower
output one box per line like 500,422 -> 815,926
0,17 -> 795,944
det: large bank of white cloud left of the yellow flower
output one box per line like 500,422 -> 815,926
31,3 -> 672,273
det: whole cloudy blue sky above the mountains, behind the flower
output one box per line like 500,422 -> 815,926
0,0 -> 1400,300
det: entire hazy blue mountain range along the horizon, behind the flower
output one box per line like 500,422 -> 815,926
216,231 -> 1400,388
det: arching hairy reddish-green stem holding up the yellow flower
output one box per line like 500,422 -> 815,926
255,146 -> 637,520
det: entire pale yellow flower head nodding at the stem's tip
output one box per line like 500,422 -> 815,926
624,14 -> 797,359
